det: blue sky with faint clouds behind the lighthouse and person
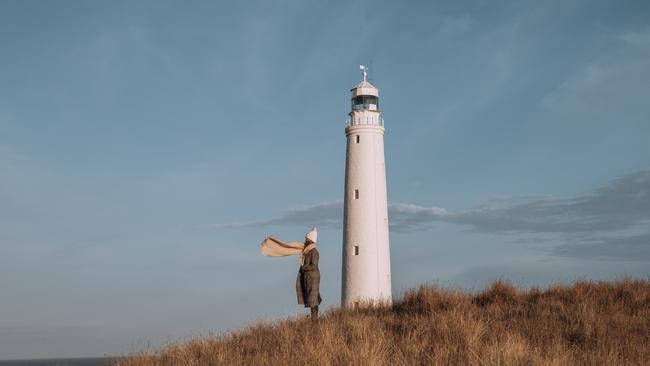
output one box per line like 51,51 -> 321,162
0,0 -> 650,359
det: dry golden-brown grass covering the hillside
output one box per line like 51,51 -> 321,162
116,279 -> 650,366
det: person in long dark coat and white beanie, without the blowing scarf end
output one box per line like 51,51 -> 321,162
296,228 -> 323,320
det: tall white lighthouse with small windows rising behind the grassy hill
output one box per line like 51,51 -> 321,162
341,65 -> 392,306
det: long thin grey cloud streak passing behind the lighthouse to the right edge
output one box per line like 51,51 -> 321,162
217,170 -> 650,235
